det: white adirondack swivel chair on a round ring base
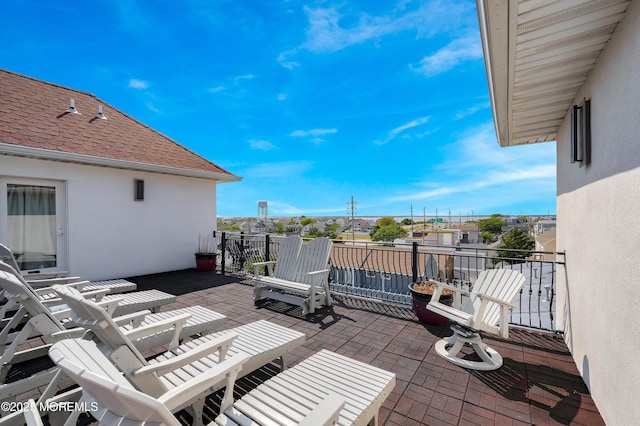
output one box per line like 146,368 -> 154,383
427,269 -> 526,370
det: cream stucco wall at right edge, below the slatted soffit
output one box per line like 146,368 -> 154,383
557,2 -> 640,425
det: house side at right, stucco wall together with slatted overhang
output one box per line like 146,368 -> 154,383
478,0 -> 640,425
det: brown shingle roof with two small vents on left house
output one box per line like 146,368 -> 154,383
0,69 -> 239,181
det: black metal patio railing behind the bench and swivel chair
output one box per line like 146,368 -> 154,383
214,232 -> 564,331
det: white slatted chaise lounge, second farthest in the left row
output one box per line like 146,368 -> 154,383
0,261 -> 176,318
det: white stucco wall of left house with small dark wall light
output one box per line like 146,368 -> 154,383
0,155 -> 216,279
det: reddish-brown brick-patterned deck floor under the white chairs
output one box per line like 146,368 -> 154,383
122,270 -> 604,425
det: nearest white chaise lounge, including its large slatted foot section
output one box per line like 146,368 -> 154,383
50,340 -> 395,426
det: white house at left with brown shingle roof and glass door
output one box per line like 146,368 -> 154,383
0,70 -> 240,279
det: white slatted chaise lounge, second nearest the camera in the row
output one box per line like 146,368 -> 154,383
49,286 -> 305,424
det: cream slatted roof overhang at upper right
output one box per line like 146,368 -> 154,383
477,0 -> 630,146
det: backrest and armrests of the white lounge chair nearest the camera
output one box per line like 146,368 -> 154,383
49,333 -> 248,425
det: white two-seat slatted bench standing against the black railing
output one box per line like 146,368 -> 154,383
253,235 -> 333,315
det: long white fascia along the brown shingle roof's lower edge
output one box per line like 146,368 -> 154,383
0,143 -> 242,183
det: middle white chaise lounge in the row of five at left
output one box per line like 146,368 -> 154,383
0,271 -> 226,408
